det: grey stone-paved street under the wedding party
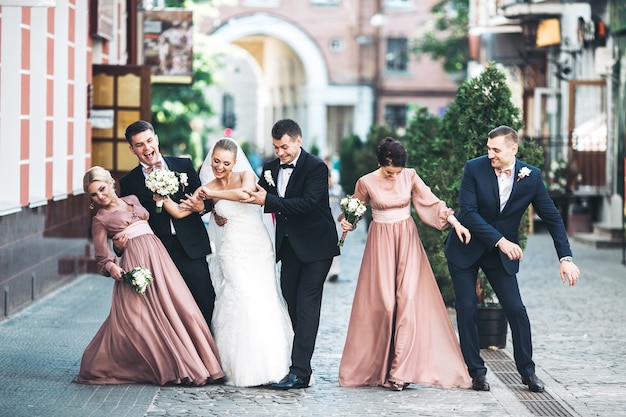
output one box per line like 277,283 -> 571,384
0,224 -> 626,417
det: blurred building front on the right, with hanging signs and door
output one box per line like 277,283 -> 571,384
469,0 -> 626,243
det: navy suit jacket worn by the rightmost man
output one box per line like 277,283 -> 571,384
444,155 -> 572,274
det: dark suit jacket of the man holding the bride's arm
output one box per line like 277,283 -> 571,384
259,149 -> 339,262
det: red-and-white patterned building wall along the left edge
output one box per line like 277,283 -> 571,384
0,0 -> 135,320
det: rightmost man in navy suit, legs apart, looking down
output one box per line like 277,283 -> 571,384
444,126 -> 580,392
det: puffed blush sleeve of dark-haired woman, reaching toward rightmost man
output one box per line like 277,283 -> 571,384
411,171 -> 454,230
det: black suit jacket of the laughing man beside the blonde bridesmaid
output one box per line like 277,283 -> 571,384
120,156 -> 211,259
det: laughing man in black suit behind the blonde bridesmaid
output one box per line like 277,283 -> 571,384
114,120 -> 215,326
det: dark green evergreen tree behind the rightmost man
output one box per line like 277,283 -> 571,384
406,63 -> 543,305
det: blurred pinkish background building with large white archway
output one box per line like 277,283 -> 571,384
198,0 -> 458,156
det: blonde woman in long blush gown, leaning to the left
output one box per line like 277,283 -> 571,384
74,166 -> 224,385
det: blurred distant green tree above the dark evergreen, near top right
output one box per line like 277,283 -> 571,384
412,0 -> 469,73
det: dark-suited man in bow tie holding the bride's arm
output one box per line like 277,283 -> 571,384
246,119 -> 339,389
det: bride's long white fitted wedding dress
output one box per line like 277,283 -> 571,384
209,200 -> 293,387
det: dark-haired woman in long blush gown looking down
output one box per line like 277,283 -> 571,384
339,138 -> 471,391
